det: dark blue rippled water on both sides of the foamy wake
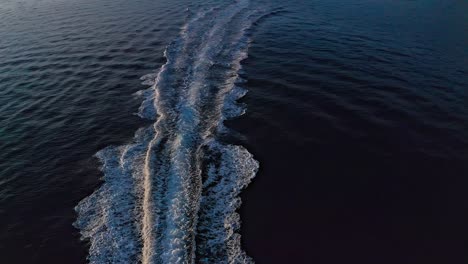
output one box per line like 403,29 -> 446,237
0,0 -> 468,264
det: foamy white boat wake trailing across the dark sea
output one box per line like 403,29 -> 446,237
75,0 -> 278,264
